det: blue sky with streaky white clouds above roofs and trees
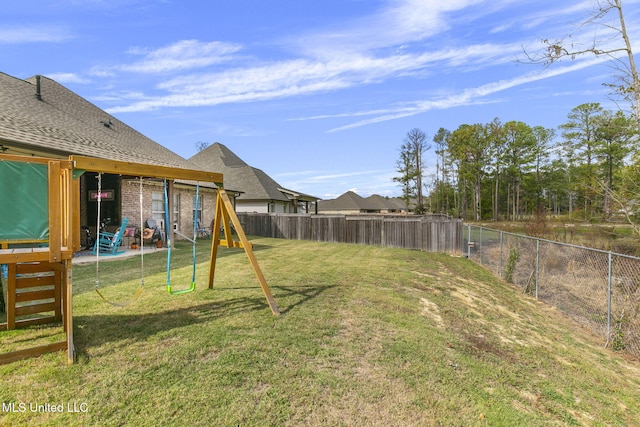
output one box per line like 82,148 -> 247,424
0,0 -> 640,198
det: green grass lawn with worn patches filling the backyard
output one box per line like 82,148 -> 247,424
0,238 -> 640,427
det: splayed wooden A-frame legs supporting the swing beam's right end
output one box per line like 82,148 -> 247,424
209,186 -> 280,316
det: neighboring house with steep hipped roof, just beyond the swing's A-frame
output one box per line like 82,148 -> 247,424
189,142 -> 318,213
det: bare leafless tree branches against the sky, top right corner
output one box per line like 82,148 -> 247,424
525,0 -> 640,125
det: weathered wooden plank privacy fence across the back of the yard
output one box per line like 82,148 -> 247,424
238,212 -> 462,252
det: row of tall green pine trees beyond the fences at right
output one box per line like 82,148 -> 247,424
394,103 -> 640,221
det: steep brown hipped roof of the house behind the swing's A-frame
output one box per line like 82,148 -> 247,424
189,142 -> 289,201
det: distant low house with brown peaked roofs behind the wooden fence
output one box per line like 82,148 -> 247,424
318,191 -> 406,215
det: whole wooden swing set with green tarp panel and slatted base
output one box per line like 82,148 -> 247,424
0,154 -> 280,364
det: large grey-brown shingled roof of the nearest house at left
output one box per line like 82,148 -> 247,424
0,73 -> 193,169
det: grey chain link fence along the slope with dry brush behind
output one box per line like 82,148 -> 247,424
463,225 -> 640,356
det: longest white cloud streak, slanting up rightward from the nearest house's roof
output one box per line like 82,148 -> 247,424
104,39 -> 520,113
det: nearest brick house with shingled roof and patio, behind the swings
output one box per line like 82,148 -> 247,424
0,73 -> 225,239
